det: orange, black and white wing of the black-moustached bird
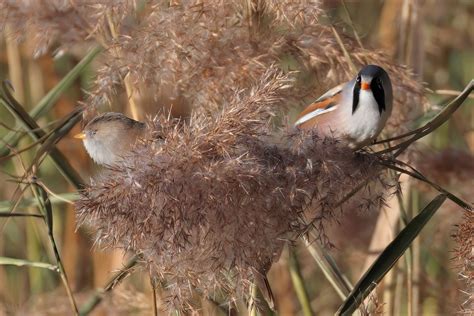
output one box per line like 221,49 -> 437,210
295,89 -> 341,128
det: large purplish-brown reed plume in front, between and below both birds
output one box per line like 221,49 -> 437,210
76,68 -> 392,309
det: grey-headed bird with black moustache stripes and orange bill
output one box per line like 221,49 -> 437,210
295,65 -> 392,150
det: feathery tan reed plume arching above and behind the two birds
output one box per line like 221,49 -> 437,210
85,1 -> 426,131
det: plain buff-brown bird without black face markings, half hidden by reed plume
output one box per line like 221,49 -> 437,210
74,112 -> 145,165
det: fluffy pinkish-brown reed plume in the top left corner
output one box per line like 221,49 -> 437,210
0,0 -> 135,57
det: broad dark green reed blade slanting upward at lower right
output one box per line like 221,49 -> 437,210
336,194 -> 446,315
